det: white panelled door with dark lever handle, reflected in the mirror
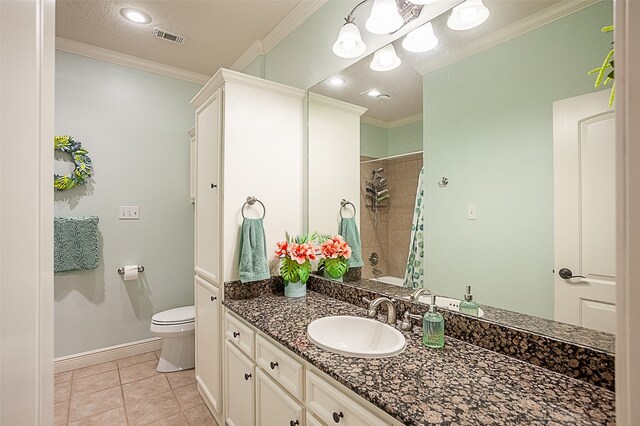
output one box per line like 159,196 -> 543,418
553,90 -> 616,333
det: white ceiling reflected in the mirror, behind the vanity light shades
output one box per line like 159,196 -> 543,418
310,0 -> 567,122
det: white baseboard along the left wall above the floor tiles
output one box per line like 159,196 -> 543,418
54,337 -> 162,373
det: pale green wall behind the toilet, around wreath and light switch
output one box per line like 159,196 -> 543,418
52,51 -> 201,357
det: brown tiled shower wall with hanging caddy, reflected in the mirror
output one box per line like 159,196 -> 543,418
360,152 -> 423,286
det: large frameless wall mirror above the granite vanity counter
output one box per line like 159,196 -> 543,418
309,0 -> 615,351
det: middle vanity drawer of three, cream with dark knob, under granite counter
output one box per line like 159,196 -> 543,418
255,335 -> 304,401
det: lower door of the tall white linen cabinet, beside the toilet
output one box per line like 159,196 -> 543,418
195,276 -> 222,419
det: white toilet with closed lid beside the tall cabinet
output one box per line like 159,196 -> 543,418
150,306 -> 196,373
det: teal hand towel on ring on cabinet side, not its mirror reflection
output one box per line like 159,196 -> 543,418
238,219 -> 270,283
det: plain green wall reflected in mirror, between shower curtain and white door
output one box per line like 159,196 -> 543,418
423,1 -> 613,318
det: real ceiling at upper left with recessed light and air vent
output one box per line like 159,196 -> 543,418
56,0 -> 301,75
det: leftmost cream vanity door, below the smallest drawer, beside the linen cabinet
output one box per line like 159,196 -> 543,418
224,340 -> 256,426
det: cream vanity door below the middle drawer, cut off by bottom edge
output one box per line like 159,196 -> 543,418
256,369 -> 304,426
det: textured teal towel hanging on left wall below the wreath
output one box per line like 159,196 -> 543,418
53,216 -> 99,272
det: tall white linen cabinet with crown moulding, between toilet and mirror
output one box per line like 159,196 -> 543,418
191,69 -> 304,424
